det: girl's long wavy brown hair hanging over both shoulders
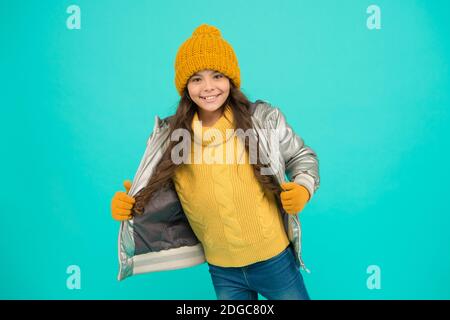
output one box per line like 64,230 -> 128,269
132,81 -> 282,214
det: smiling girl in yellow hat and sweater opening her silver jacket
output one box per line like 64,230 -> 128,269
111,24 -> 319,300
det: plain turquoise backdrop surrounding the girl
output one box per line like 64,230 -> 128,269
0,0 -> 450,299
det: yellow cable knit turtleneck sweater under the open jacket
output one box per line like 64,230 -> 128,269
173,106 -> 289,267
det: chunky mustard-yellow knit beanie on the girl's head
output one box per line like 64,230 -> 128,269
175,24 -> 241,96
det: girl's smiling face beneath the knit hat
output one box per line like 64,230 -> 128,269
187,69 -> 230,113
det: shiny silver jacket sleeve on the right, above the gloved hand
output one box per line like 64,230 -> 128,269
274,108 -> 320,200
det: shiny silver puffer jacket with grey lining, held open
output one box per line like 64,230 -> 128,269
118,100 -> 319,280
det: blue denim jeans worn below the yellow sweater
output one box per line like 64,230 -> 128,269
208,245 -> 310,300
